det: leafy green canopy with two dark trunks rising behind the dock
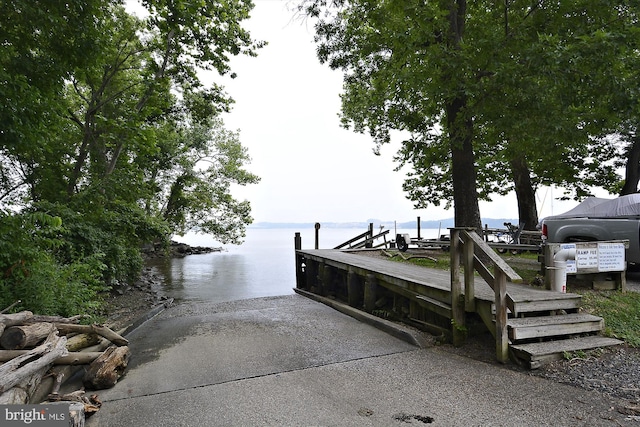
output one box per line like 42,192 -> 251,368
303,0 -> 637,227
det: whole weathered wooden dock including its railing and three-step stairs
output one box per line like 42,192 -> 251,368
296,229 -> 620,368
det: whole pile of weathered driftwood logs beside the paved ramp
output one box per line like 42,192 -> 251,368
0,311 -> 130,416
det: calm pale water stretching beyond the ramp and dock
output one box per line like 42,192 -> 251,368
150,228 -> 438,302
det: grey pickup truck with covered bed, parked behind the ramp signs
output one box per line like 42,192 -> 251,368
539,194 -> 640,264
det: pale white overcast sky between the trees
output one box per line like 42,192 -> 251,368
194,0 -> 576,222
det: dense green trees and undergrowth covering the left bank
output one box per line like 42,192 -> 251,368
0,0 -> 264,314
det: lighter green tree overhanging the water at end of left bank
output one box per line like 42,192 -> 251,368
146,115 -> 259,244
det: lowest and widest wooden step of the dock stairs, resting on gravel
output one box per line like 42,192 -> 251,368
509,335 -> 623,369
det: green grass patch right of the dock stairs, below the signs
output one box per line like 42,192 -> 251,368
572,289 -> 640,347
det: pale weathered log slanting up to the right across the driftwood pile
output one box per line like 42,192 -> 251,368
0,330 -> 68,393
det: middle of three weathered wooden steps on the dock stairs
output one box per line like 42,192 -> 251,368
507,313 -> 604,342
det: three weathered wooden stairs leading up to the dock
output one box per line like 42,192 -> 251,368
488,291 -> 622,369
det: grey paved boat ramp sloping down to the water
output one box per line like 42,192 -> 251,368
86,295 -> 639,427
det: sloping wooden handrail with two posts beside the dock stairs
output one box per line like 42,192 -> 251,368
449,227 -> 522,363
